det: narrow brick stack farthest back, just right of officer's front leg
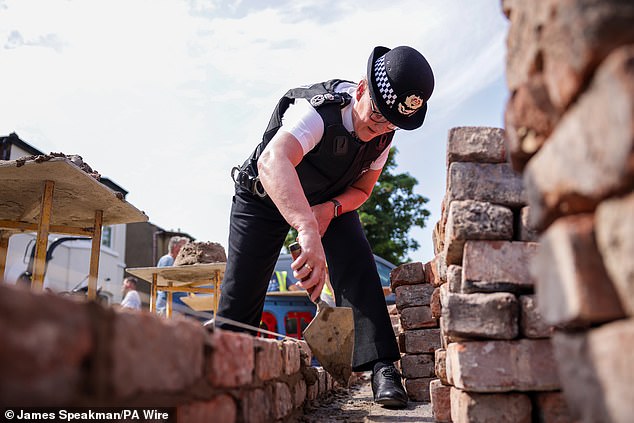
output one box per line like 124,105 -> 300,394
390,262 -> 440,402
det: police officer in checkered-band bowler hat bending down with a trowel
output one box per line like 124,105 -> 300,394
218,46 -> 434,407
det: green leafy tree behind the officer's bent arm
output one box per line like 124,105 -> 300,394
284,147 -> 429,265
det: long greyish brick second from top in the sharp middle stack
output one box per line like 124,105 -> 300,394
447,162 -> 526,207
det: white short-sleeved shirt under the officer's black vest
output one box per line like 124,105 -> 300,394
280,82 -> 392,170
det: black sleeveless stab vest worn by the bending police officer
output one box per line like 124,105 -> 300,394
241,79 -> 394,206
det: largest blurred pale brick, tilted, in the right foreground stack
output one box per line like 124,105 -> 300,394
524,47 -> 634,230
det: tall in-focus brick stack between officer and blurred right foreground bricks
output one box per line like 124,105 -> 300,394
426,127 -> 567,423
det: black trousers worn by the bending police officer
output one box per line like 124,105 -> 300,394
218,189 -> 400,371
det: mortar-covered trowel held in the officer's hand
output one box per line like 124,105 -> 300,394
289,242 -> 354,386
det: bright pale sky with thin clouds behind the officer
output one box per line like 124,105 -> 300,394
0,0 -> 508,262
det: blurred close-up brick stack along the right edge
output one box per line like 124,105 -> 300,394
502,0 -> 634,422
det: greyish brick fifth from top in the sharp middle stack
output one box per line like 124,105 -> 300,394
442,292 -> 519,339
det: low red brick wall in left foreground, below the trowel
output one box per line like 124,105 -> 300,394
0,284 -> 334,423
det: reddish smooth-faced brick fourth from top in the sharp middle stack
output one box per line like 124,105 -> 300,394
462,241 -> 538,293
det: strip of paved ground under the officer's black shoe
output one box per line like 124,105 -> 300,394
298,373 -> 434,423
